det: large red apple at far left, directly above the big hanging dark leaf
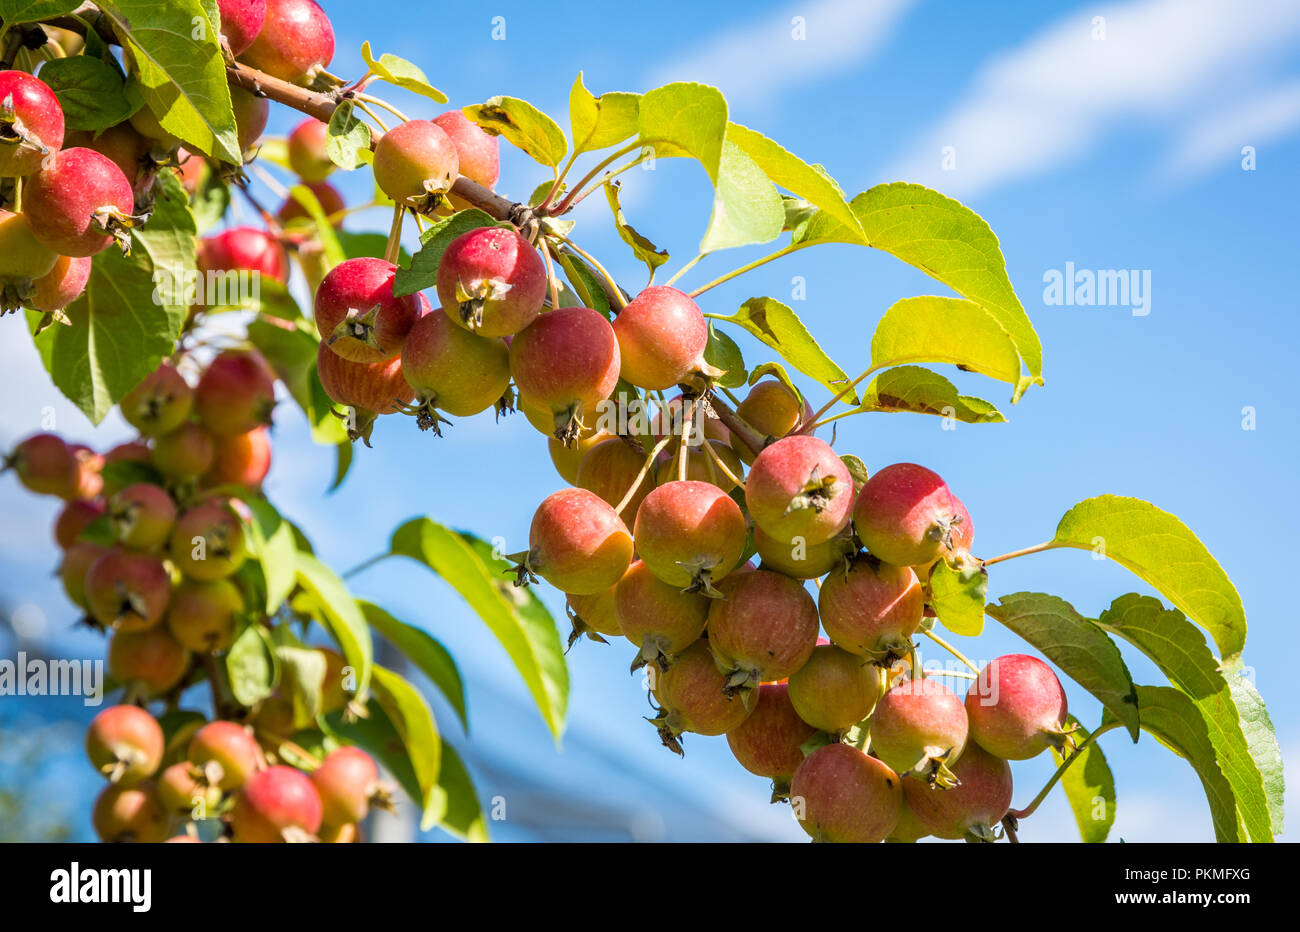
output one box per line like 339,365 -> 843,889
22,148 -> 135,256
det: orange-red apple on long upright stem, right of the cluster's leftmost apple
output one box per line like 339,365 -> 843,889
636,480 -> 746,595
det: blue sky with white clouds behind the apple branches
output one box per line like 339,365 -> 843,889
0,0 -> 1300,841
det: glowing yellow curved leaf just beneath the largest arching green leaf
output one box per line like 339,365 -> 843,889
871,295 -> 1021,385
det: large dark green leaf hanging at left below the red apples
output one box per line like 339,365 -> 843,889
29,172 -> 196,424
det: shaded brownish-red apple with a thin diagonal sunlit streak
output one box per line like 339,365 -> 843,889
818,555 -> 926,663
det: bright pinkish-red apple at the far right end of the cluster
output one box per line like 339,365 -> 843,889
966,654 -> 1067,760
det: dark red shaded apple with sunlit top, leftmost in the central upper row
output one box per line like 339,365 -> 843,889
315,256 -> 418,361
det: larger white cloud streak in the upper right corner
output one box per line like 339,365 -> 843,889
887,0 -> 1300,195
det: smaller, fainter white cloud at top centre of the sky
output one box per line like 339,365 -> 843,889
649,0 -> 915,104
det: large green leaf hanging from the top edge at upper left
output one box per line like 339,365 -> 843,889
98,0 -> 242,165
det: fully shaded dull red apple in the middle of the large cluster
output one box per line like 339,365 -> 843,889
709,569 -> 818,701
